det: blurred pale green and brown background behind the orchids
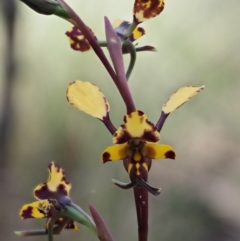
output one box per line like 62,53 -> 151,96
0,0 -> 240,241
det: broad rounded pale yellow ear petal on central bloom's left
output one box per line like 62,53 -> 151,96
67,80 -> 110,120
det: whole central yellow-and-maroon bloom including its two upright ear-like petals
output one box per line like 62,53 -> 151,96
67,80 -> 204,195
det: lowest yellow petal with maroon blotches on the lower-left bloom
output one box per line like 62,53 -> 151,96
19,200 -> 51,219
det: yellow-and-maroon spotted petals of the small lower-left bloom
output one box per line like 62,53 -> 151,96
19,162 -> 78,230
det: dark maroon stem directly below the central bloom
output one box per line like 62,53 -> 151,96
133,186 -> 148,241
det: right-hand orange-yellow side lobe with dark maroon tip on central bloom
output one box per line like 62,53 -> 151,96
143,142 -> 176,159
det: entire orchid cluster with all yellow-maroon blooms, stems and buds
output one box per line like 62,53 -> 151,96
18,0 -> 204,241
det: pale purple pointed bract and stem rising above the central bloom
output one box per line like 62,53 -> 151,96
104,17 -> 136,113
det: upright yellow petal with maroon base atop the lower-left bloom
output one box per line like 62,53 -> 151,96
34,162 -> 71,200
